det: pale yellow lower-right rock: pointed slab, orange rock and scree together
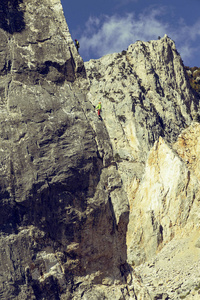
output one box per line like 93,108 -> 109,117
127,123 -> 200,300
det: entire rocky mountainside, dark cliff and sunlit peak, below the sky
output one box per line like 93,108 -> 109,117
0,0 -> 200,300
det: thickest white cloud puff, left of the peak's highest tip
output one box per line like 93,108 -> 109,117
80,11 -> 167,57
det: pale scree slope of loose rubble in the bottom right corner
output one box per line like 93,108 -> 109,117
136,231 -> 200,300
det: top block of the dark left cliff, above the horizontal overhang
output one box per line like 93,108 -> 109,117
0,0 -> 85,85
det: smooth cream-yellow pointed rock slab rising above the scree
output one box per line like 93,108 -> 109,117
127,137 -> 199,265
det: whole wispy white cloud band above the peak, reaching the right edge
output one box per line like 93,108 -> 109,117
80,8 -> 200,65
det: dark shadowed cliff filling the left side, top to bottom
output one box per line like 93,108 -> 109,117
0,0 -> 131,299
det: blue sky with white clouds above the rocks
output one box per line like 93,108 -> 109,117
61,0 -> 200,67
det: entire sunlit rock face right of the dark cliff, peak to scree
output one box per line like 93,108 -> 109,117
85,36 -> 200,299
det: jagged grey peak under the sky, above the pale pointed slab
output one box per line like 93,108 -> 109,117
85,36 -> 198,168
